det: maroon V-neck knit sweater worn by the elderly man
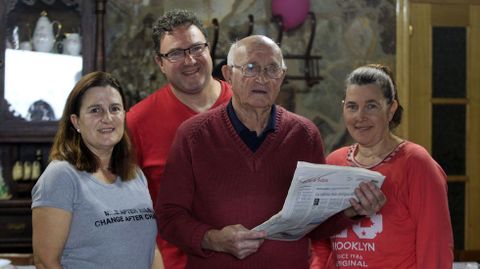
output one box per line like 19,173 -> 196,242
156,105 -> 352,269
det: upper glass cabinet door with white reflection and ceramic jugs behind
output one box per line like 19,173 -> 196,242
0,0 -> 95,138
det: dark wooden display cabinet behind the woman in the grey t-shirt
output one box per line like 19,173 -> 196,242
0,0 -> 105,252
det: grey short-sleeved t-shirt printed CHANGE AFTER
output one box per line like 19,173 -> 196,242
32,161 -> 157,269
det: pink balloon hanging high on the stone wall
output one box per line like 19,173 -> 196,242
272,0 -> 310,31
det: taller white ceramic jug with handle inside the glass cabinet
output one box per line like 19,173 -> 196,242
32,11 -> 62,52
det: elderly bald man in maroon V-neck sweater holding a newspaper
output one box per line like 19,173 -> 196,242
156,35 -> 385,269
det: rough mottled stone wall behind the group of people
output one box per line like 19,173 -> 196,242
106,0 -> 396,153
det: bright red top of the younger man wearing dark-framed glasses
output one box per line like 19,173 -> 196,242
127,81 -> 232,269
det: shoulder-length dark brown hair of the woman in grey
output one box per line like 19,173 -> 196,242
49,71 -> 136,180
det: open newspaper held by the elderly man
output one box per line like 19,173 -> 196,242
253,161 -> 385,241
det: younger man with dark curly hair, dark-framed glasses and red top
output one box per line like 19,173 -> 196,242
127,10 -> 232,269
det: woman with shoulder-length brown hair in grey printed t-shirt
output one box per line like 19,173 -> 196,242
32,72 -> 163,269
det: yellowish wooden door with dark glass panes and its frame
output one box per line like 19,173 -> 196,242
397,0 -> 480,250
